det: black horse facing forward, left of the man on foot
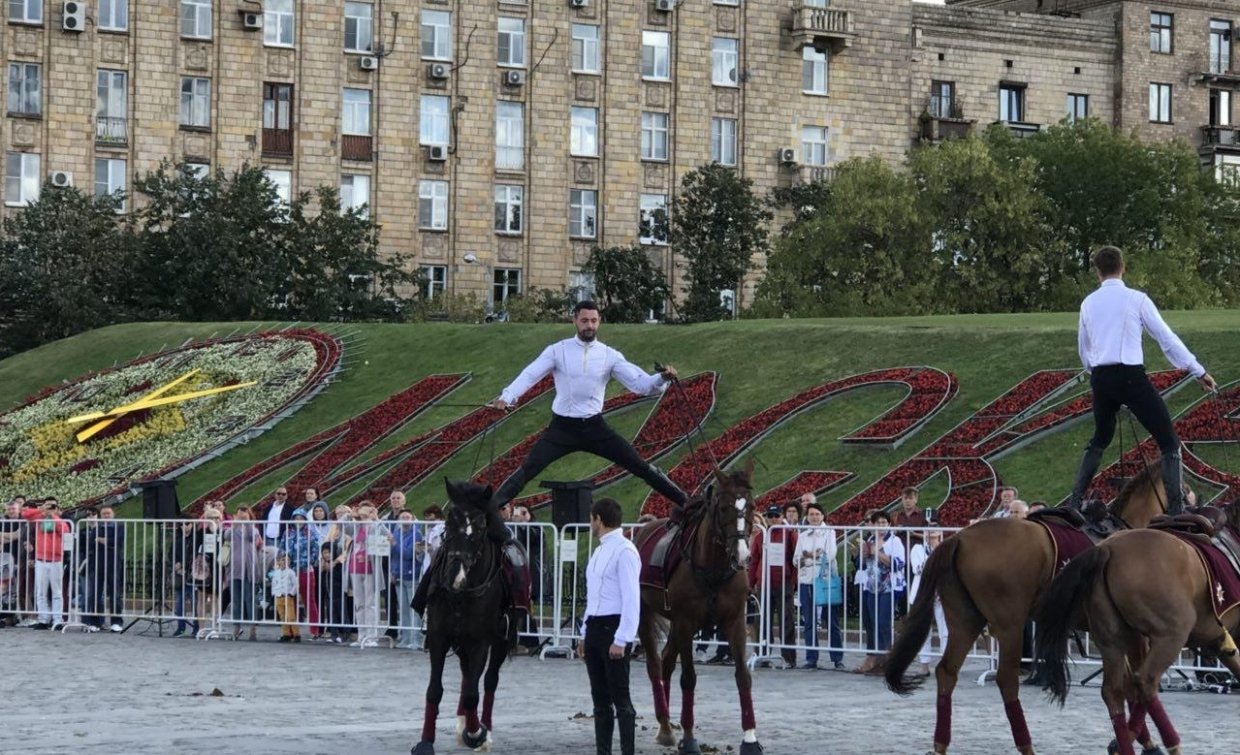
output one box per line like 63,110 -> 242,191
413,481 -> 517,755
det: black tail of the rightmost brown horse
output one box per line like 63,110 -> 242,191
1034,548 -> 1111,707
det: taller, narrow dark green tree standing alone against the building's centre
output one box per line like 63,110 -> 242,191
670,162 -> 771,322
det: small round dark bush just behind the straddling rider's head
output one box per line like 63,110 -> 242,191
582,244 -> 670,322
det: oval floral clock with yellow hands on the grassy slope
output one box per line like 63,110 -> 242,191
0,330 -> 341,508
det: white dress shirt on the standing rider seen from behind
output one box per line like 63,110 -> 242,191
1076,278 -> 1205,377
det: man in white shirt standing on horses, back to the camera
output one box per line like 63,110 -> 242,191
1069,247 -> 1218,514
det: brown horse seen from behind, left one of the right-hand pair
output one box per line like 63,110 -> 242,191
884,465 -> 1167,755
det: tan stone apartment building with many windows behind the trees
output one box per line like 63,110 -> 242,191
0,0 -> 1240,309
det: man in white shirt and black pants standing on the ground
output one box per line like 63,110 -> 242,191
582,498 -> 639,755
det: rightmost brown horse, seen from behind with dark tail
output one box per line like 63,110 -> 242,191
1038,505 -> 1240,755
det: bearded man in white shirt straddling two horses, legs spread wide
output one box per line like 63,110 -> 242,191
487,301 -> 687,508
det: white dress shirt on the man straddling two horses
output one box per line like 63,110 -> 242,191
500,336 -> 667,419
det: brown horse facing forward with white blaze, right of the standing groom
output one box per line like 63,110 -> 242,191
634,462 -> 763,755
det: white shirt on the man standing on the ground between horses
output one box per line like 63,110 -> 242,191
582,529 -> 641,645
